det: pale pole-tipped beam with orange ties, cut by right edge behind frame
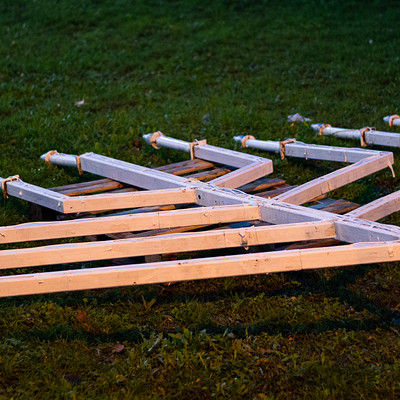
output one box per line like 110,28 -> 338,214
311,124 -> 400,147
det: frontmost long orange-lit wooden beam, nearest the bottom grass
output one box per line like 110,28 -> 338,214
0,243 -> 400,297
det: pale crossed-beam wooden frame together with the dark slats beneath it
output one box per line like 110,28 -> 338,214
0,133 -> 400,296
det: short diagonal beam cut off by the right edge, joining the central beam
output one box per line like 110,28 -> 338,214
347,191 -> 400,221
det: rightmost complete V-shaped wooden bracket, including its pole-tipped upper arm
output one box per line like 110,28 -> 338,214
234,136 -> 394,204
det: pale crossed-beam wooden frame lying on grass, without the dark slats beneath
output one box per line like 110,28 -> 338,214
0,132 -> 400,297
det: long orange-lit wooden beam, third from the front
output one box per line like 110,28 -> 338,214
0,204 -> 260,243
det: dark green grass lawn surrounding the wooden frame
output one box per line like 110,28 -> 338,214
0,0 -> 400,399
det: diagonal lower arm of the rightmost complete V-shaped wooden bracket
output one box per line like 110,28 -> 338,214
277,153 -> 394,205
